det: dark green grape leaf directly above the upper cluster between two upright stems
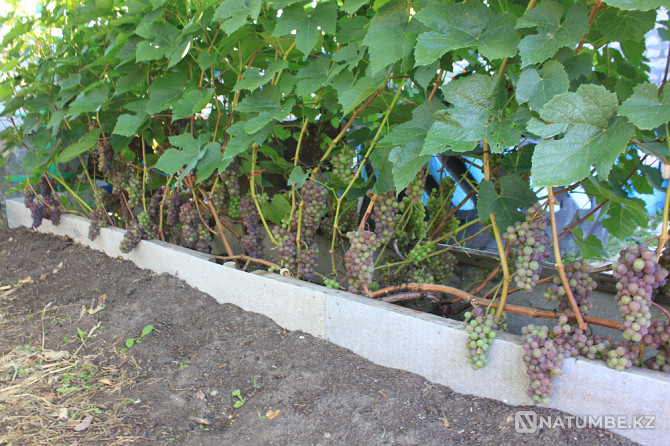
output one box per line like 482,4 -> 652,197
477,175 -> 537,231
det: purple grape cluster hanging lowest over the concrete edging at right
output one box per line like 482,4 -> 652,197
521,317 -> 572,403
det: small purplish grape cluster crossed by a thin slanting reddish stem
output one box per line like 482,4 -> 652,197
544,260 -> 597,316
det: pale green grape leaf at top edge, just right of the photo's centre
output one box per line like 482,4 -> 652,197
363,0 -> 414,73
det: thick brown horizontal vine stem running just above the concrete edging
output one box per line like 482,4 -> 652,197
370,283 -> 622,330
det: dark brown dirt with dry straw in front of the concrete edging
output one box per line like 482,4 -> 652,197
0,229 -> 631,445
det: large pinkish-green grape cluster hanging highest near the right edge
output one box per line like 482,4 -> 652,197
613,244 -> 668,342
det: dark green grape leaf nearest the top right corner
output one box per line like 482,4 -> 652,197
594,8 -> 656,42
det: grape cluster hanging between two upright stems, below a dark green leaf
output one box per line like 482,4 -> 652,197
503,204 -> 550,293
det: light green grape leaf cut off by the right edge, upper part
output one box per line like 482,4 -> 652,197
619,82 -> 670,130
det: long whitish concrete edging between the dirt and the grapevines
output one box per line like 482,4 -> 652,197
6,200 -> 670,445
